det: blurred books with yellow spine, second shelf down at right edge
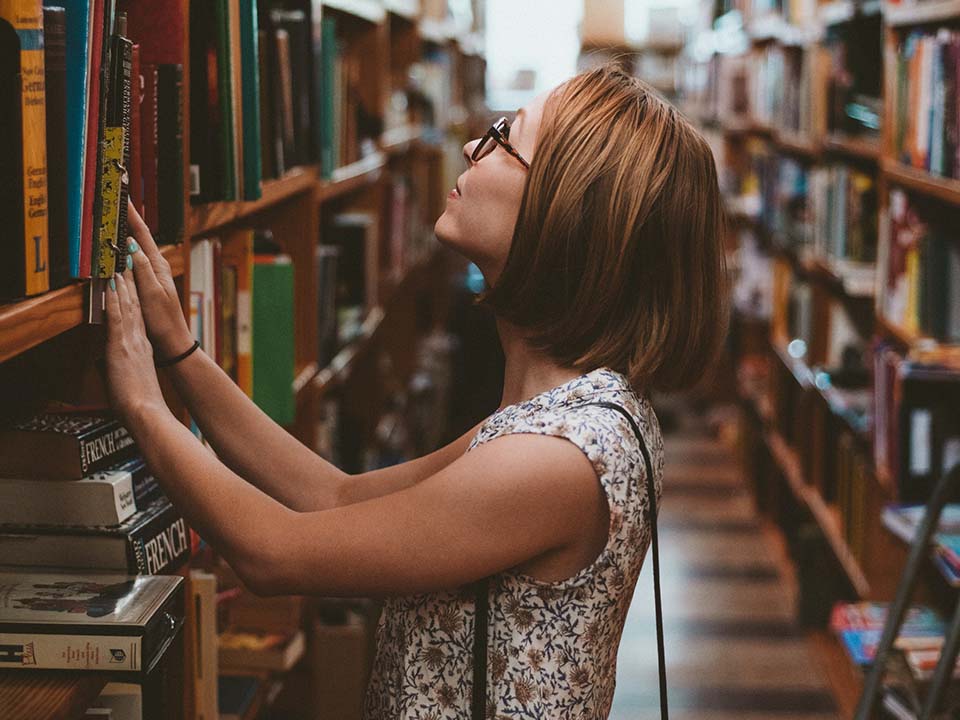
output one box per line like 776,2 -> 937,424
879,189 -> 960,342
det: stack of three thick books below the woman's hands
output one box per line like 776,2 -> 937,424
0,414 -> 193,575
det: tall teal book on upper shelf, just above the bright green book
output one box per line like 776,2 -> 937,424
240,0 -> 263,200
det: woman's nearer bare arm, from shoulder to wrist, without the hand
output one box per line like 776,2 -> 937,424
130,406 -> 604,596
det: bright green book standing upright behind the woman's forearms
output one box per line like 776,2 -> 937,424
253,255 -> 296,425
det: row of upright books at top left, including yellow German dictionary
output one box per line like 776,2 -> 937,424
0,0 -> 184,300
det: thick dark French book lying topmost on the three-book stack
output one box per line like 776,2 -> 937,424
0,414 -> 135,480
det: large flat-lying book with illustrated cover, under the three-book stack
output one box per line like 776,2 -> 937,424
0,571 -> 184,677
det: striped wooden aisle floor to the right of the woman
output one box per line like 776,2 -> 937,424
610,414 -> 838,720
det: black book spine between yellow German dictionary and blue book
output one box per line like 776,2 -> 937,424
43,7 -> 70,290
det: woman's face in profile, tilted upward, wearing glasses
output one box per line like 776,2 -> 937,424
434,93 -> 548,283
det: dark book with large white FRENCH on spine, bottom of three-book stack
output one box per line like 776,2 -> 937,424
0,496 -> 192,575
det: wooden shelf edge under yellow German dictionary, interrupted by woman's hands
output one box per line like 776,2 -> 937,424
0,244 -> 185,362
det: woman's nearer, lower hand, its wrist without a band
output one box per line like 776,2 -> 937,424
106,270 -> 167,428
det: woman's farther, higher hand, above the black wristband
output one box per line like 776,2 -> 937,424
127,202 -> 193,358
